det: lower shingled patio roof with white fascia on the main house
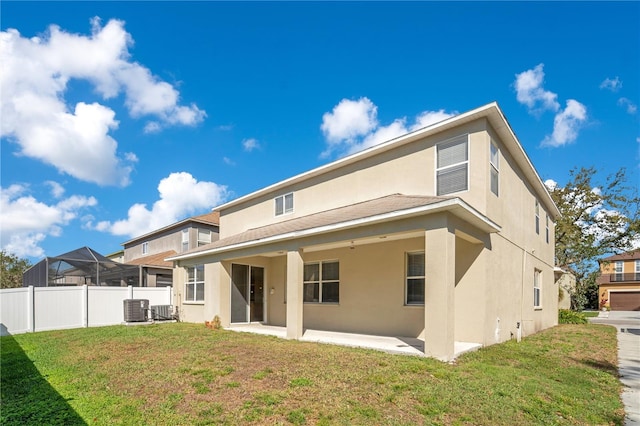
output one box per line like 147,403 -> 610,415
166,194 -> 500,261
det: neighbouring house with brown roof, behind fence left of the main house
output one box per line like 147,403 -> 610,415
122,212 -> 220,287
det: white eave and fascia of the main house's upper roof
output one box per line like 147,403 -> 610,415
214,102 -> 560,219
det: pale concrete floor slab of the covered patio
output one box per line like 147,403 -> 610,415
227,323 -> 482,359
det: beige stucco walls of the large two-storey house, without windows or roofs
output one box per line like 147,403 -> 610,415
171,111 -> 558,354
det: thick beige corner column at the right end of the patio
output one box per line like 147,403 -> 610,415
424,220 -> 456,361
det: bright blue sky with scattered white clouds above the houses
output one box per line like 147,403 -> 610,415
0,1 -> 640,262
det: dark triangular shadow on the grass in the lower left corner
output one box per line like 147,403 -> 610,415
0,324 -> 87,425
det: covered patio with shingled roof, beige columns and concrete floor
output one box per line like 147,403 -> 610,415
169,194 -> 499,361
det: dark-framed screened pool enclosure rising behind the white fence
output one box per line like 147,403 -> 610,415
22,247 -> 140,287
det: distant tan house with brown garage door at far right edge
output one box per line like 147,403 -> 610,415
598,250 -> 640,311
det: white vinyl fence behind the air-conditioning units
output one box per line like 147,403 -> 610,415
0,285 -> 172,336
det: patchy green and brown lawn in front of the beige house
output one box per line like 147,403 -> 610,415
0,323 -> 624,425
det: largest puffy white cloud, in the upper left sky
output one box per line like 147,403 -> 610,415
0,18 -> 206,186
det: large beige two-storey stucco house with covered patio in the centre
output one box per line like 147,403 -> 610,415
167,103 -> 559,360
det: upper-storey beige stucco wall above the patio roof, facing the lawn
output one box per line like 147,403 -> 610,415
220,120 -> 488,238
